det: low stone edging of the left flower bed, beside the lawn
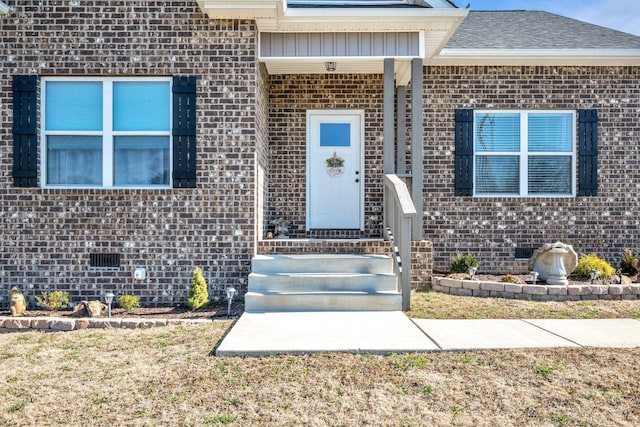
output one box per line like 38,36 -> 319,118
0,316 -> 213,332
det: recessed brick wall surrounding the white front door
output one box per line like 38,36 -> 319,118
269,74 -> 383,238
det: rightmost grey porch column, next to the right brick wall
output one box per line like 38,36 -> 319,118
411,58 -> 424,240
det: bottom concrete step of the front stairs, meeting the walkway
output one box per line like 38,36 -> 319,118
245,292 -> 402,313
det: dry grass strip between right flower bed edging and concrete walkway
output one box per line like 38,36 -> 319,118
407,292 -> 640,319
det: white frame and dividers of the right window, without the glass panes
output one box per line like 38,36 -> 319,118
472,110 -> 578,199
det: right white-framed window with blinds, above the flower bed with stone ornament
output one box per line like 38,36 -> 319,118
473,111 -> 576,197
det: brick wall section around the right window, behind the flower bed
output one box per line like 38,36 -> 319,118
424,67 -> 640,273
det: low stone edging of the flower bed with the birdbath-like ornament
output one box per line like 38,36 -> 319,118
433,277 -> 640,301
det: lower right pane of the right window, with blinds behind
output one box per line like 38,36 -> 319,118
528,156 -> 573,195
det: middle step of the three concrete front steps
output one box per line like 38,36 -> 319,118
249,273 -> 398,292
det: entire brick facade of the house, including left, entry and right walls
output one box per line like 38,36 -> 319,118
0,0 -> 640,306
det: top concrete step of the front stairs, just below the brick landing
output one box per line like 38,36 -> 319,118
251,254 -> 393,274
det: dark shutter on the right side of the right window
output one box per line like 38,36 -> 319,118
578,110 -> 598,196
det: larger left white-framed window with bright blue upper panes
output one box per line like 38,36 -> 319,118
42,78 -> 171,188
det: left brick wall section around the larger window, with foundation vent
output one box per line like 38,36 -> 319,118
0,0 -> 264,306
